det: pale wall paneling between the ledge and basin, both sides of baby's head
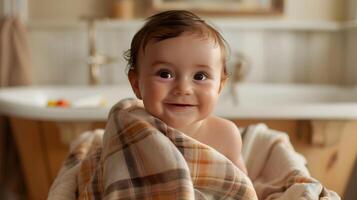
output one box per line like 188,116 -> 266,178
30,27 -> 348,85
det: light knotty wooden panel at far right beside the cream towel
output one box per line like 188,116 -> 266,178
290,122 -> 357,197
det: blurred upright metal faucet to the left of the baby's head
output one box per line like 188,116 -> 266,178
86,18 -> 117,85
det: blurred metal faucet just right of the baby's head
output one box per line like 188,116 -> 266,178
230,53 -> 250,105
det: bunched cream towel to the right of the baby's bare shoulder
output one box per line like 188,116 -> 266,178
242,124 -> 340,200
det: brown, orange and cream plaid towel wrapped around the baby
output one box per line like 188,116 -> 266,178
48,99 -> 257,200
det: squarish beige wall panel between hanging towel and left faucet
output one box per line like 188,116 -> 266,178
29,29 -> 88,85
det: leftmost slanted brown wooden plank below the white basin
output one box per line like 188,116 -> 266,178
10,118 -> 50,200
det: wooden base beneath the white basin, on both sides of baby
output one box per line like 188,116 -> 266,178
11,118 -> 357,200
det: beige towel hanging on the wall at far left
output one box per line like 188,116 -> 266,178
0,17 -> 31,87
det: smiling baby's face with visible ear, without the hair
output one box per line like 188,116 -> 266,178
129,34 -> 223,128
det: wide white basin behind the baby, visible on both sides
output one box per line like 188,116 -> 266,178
0,84 -> 357,121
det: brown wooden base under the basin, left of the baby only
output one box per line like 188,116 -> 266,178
11,118 -> 105,200
